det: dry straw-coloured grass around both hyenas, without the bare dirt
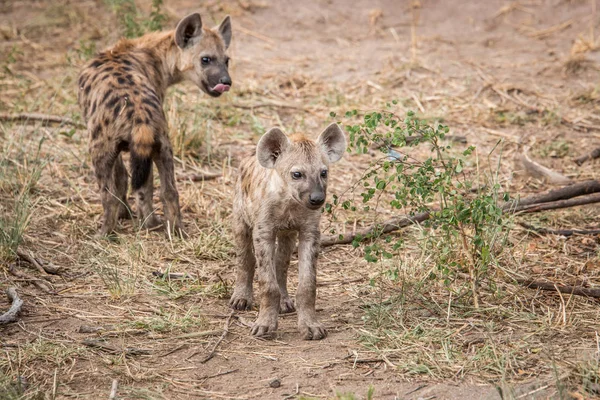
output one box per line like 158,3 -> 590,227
0,2 -> 600,399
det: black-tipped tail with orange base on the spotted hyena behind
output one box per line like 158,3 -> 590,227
129,124 -> 154,190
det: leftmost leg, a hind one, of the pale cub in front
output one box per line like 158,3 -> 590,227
229,217 -> 256,311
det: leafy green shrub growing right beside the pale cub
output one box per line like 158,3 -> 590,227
325,102 -> 508,308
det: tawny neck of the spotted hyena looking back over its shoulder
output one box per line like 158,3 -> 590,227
123,31 -> 183,98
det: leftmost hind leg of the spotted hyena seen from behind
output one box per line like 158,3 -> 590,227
92,149 -> 121,236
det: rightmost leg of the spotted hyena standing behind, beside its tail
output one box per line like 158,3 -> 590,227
154,139 -> 186,236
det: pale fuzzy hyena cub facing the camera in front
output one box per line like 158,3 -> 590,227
229,124 -> 346,340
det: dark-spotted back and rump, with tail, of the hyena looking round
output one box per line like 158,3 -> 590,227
78,41 -> 167,189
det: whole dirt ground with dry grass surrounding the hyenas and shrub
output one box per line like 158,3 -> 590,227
0,0 -> 600,399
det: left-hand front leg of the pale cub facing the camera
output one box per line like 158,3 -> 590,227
252,225 -> 281,336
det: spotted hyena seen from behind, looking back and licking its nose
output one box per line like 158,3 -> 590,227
79,14 -> 231,235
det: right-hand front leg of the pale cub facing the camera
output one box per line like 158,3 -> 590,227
296,225 -> 327,340
